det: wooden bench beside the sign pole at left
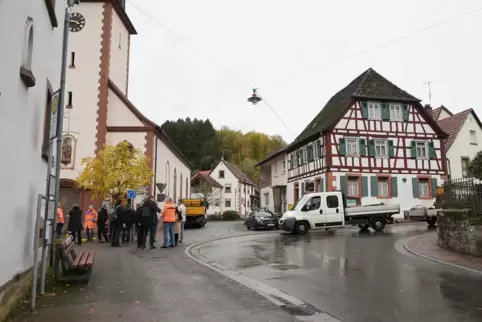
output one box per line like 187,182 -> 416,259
59,237 -> 95,284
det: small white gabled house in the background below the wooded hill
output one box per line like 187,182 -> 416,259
209,159 -> 259,216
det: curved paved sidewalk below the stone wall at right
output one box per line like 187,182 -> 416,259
404,232 -> 482,274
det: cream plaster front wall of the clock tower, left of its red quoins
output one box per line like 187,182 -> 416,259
60,2 -> 104,180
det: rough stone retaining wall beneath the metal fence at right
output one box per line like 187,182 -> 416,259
437,209 -> 482,256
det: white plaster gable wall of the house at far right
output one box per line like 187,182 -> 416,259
447,113 -> 482,179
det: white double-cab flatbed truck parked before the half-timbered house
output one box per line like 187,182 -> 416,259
279,191 -> 400,234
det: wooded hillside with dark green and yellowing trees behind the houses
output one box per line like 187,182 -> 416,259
162,117 -> 286,182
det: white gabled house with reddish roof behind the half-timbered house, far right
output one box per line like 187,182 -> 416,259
432,105 -> 482,179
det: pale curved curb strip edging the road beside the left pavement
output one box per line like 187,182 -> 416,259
184,231 -> 341,322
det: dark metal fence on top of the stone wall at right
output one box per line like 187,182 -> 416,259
443,178 -> 482,213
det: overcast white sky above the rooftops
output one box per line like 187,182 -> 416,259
127,0 -> 482,142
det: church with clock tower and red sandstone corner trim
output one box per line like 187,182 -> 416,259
60,0 -> 192,210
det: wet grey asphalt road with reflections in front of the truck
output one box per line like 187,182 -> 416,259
196,223 -> 482,322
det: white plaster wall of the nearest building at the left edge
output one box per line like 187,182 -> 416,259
0,1 -> 65,286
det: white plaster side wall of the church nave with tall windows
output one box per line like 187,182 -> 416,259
153,138 -> 191,207
